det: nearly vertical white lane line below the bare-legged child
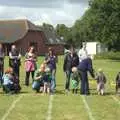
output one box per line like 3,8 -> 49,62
46,95 -> 54,120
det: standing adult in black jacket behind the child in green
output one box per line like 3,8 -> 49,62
63,47 -> 79,92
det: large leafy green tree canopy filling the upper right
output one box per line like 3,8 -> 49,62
56,0 -> 120,50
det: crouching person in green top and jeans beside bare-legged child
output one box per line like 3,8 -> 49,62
32,64 -> 45,92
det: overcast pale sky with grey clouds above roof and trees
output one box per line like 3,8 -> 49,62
0,0 -> 88,26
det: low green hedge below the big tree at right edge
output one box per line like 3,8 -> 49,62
95,52 -> 120,60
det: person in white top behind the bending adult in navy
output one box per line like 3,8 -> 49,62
78,43 -> 88,62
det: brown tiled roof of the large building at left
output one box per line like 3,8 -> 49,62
0,20 -> 40,43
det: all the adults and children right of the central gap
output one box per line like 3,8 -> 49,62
63,44 -> 120,95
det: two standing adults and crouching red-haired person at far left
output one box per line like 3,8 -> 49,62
0,44 -> 21,93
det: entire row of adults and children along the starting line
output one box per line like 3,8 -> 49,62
0,44 -> 120,95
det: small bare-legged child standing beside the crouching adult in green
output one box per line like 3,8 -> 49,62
43,67 -> 52,93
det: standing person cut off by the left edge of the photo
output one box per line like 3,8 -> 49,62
0,44 -> 5,84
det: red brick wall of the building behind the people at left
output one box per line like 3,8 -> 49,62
15,31 -> 64,55
